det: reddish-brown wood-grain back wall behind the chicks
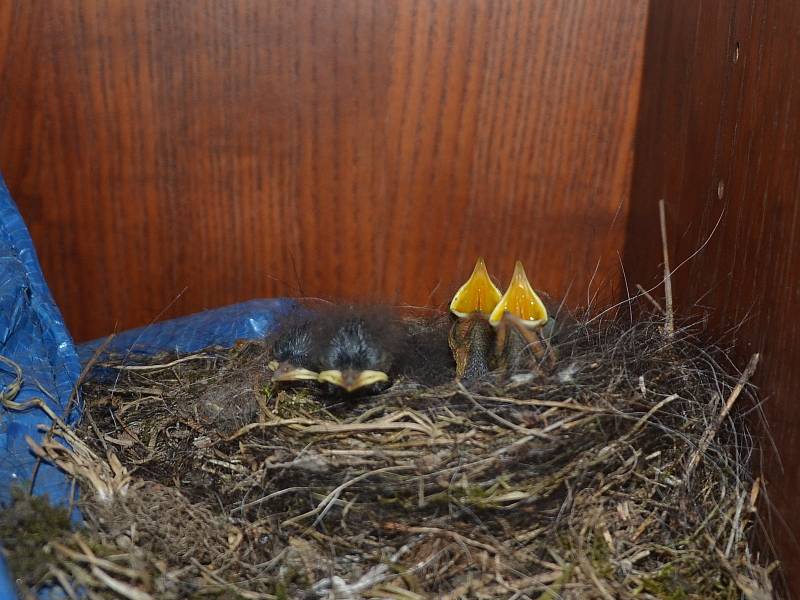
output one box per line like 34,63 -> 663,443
0,0 -> 647,340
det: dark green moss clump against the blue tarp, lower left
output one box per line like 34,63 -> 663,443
0,486 -> 71,584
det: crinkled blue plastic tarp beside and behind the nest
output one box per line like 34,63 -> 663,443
0,177 -> 296,600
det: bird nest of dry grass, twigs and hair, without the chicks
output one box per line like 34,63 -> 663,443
0,310 -> 776,600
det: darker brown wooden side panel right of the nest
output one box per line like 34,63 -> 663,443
625,0 -> 800,597
